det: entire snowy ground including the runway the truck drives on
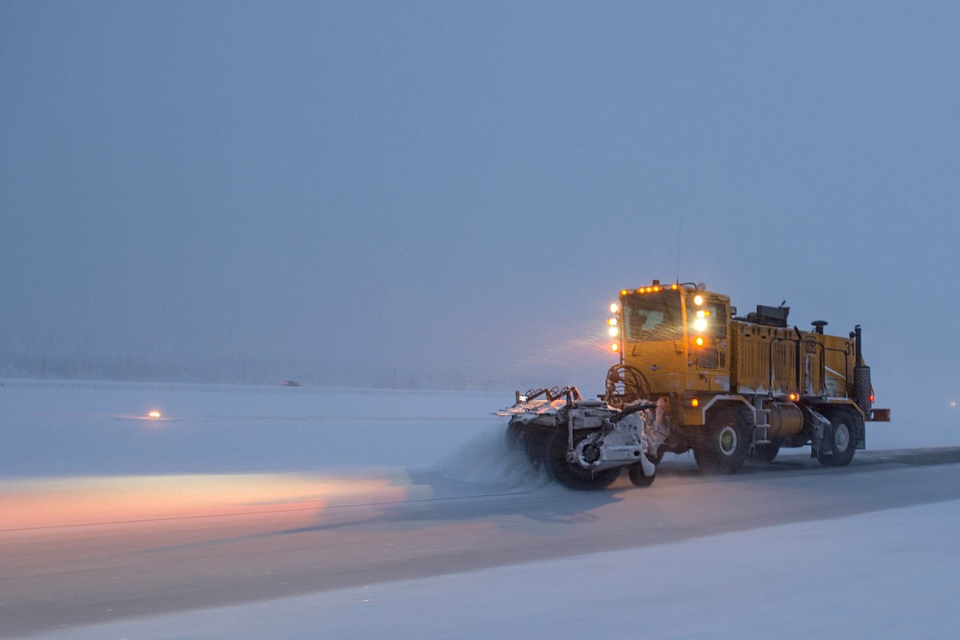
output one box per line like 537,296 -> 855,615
0,383 -> 960,638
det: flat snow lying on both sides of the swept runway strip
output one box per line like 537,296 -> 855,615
0,380 -> 960,639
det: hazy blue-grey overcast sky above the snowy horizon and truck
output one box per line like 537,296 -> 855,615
0,0 -> 960,404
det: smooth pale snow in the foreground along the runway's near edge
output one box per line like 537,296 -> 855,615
26,501 -> 960,640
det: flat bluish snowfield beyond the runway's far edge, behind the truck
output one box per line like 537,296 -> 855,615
0,380 -> 960,485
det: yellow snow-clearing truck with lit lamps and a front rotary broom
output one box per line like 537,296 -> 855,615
500,280 -> 890,489
